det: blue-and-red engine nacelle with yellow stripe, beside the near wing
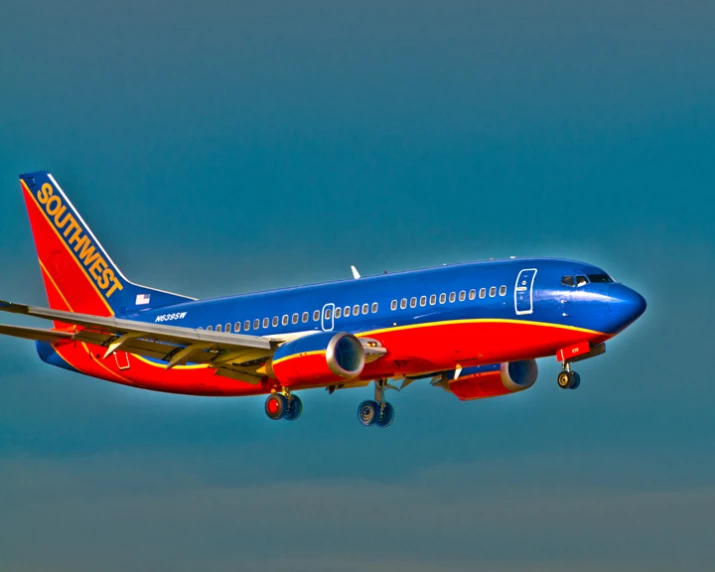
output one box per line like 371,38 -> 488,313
271,332 -> 365,387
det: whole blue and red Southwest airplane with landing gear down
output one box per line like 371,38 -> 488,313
0,171 -> 646,428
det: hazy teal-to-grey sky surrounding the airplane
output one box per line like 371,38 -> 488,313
0,0 -> 715,572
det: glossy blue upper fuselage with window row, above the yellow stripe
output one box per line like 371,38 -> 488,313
128,258 -> 645,356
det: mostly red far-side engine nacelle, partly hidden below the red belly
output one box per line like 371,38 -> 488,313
448,359 -> 539,401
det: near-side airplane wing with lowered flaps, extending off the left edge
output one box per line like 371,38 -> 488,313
0,300 -> 278,383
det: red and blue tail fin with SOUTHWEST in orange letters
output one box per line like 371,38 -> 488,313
20,171 -> 192,316
